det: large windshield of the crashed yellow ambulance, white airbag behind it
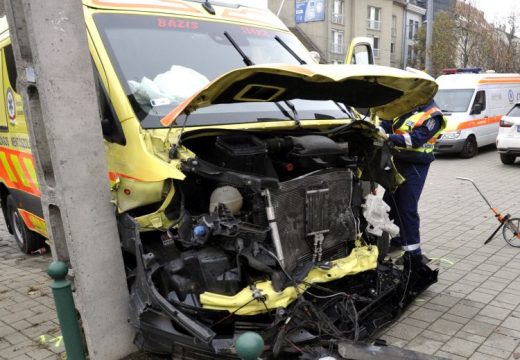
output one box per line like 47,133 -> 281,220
94,14 -> 345,128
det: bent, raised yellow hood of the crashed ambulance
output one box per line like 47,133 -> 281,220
161,64 -> 437,126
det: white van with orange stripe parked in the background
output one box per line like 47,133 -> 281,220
435,73 -> 520,158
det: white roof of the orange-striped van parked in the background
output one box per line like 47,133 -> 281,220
437,73 -> 520,89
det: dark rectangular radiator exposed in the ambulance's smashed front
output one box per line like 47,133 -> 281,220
271,170 -> 356,271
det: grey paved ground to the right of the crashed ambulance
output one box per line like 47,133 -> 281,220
383,149 -> 520,360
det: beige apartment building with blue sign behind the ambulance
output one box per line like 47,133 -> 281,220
268,0 -> 426,68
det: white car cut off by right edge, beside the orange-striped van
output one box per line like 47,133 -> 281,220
497,102 -> 520,165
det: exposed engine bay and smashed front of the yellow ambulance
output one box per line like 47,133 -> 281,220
121,126 -> 436,358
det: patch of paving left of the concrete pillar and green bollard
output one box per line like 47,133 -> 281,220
0,229 -> 64,360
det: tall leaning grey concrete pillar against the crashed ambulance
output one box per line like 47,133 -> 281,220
6,0 -> 135,360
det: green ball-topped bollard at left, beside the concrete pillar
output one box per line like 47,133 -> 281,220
47,261 -> 85,360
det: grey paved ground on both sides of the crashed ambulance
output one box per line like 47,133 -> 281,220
0,150 -> 520,360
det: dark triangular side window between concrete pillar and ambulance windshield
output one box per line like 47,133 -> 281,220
96,75 -> 126,145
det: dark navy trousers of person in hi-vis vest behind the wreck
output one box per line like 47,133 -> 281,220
383,161 -> 430,254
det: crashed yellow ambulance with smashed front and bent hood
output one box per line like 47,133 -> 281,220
0,0 -> 437,359
